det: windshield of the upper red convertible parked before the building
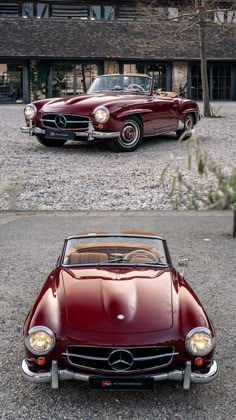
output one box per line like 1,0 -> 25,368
88,74 -> 152,95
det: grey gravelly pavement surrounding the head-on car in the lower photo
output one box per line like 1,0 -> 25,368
0,211 -> 236,420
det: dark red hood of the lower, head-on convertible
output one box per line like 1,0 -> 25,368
61,267 -> 173,334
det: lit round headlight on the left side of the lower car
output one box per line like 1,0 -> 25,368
25,326 -> 55,355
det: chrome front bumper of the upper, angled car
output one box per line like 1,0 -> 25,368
20,124 -> 120,140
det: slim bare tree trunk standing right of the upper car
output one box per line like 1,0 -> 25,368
199,18 -> 211,117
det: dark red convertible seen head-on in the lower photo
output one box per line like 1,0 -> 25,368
22,232 -> 217,390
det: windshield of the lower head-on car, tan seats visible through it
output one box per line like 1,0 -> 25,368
62,234 -> 168,266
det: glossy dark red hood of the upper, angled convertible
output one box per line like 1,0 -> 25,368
41,93 -> 146,113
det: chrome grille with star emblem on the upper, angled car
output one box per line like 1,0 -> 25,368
41,114 -> 91,130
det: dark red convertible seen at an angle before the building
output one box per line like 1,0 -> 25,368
21,74 -> 199,152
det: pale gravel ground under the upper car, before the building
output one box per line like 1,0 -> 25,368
0,103 -> 236,210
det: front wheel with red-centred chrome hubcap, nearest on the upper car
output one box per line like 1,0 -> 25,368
111,115 -> 143,152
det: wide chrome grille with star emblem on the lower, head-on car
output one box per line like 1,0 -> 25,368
63,346 -> 178,373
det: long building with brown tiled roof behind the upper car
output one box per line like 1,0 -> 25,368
0,0 -> 236,103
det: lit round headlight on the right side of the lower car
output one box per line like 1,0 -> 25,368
185,327 -> 215,356
